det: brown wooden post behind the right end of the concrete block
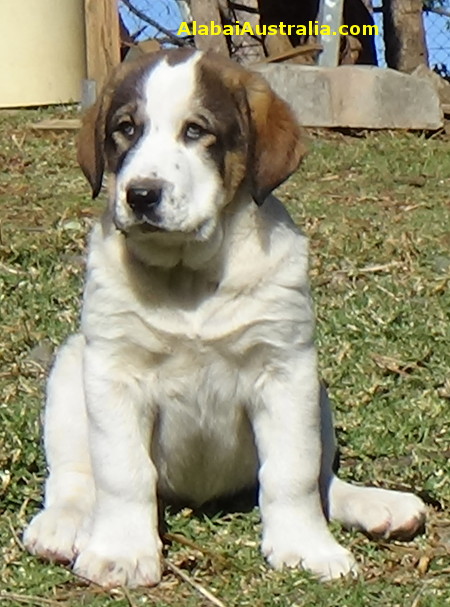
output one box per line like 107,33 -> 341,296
383,0 -> 428,72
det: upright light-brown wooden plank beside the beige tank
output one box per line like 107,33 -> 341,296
84,0 -> 120,93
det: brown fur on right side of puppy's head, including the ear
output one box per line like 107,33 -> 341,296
200,53 -> 306,204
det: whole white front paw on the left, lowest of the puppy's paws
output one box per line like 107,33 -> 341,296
74,530 -> 161,588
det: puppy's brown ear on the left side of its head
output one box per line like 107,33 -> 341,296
77,95 -> 105,198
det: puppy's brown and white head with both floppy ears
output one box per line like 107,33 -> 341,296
78,49 -> 304,240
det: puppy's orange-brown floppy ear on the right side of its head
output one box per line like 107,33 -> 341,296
245,74 -> 306,205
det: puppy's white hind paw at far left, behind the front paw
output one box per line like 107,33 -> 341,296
23,506 -> 87,563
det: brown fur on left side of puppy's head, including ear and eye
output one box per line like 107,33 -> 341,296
77,49 -> 194,198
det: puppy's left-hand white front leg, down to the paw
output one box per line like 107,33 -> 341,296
74,345 -> 161,587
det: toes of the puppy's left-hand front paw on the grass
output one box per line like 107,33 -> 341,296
74,549 -> 161,588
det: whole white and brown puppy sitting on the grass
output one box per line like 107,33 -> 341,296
25,50 -> 425,586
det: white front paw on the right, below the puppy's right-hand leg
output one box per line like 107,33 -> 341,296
262,531 -> 358,581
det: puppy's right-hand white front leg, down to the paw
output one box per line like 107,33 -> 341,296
253,348 -> 355,580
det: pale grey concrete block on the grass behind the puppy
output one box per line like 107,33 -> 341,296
254,64 -> 443,130
